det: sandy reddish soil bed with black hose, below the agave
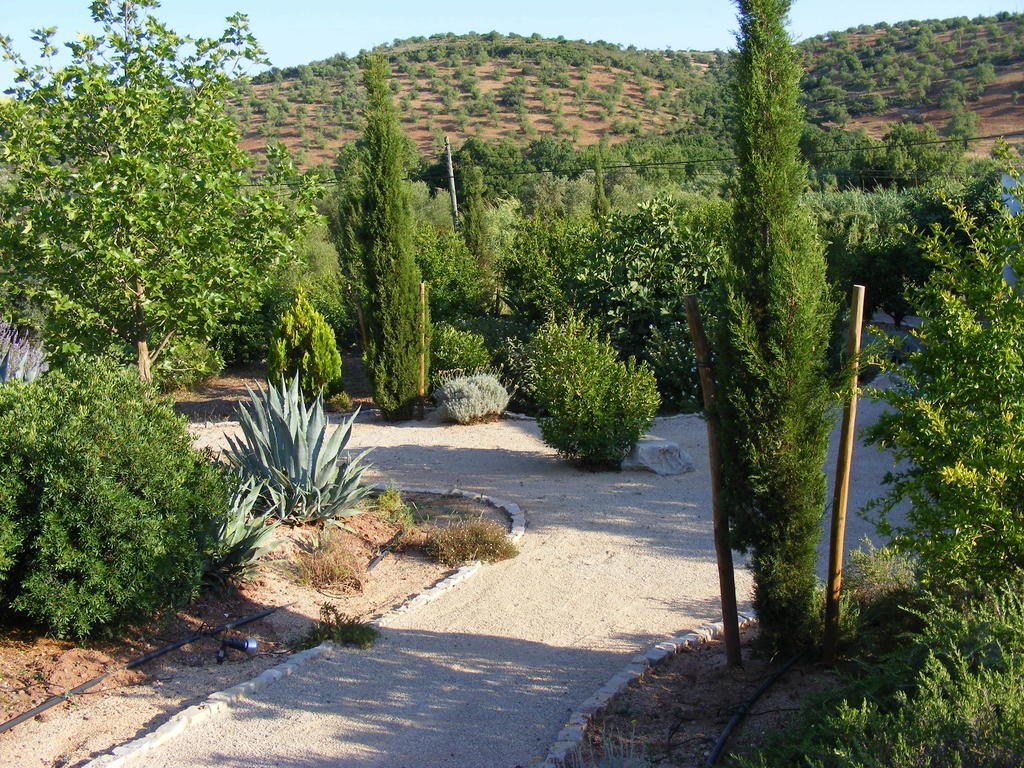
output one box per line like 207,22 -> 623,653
0,494 -> 509,768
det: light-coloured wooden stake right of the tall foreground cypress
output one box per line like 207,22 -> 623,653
822,286 -> 864,664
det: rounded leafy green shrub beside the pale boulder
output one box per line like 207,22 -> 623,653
527,315 -> 659,468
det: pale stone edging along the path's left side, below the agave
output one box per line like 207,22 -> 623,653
83,483 -> 526,768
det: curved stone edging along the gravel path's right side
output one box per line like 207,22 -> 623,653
541,611 -> 758,768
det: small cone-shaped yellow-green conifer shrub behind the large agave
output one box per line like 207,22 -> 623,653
266,291 -> 343,397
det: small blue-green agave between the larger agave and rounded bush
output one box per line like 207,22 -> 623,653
203,479 -> 281,589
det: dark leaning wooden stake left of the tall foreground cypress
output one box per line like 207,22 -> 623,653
683,294 -> 743,667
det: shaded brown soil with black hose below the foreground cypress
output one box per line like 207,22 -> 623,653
574,628 -> 837,768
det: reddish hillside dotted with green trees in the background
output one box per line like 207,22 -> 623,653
232,13 -> 1024,166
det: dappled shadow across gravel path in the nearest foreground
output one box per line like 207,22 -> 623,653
145,630 -> 679,768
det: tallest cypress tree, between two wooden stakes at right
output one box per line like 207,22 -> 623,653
718,0 -> 835,650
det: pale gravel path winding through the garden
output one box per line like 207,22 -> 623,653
133,393 -> 905,768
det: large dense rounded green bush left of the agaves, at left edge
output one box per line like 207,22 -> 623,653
0,358 -> 227,639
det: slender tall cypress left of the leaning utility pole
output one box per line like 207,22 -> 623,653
359,56 -> 429,421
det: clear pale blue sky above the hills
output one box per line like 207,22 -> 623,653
0,0 -> 1024,91
